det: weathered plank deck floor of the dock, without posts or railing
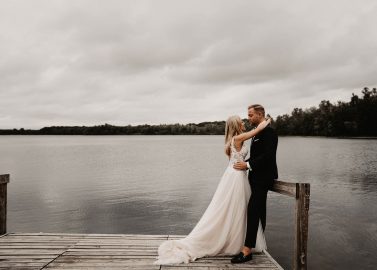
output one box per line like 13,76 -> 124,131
0,233 -> 283,270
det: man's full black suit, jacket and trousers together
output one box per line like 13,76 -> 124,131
245,126 -> 278,248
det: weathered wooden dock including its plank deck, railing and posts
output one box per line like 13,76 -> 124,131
0,174 -> 310,270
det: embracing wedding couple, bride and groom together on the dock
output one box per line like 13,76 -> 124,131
154,104 -> 278,265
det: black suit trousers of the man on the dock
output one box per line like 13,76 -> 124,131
245,183 -> 268,248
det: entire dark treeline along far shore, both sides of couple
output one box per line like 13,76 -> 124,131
0,87 -> 377,137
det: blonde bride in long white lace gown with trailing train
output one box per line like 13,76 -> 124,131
153,116 -> 271,265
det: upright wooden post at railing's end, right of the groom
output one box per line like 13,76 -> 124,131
293,183 -> 310,270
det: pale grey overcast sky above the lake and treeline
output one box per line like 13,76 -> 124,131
0,0 -> 377,128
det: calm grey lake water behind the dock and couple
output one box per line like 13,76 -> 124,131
0,136 -> 377,269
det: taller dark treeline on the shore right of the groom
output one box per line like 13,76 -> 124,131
274,87 -> 377,137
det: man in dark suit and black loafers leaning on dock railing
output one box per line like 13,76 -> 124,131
231,104 -> 278,263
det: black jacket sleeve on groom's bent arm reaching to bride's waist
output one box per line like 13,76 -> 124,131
248,129 -> 278,170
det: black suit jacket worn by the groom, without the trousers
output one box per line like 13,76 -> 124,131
248,126 -> 278,188
